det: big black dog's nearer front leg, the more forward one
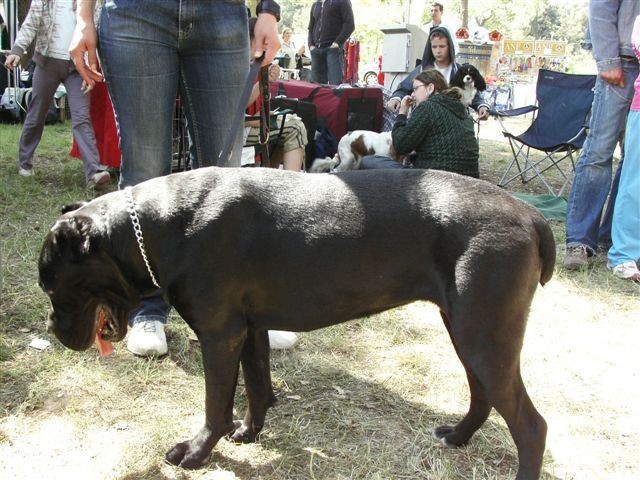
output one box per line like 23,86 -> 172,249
166,332 -> 245,468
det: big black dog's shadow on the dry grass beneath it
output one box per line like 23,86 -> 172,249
112,352 -> 559,480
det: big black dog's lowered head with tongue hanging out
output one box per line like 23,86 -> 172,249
38,211 -> 139,350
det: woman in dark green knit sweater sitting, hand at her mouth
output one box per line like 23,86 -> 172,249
360,69 -> 479,178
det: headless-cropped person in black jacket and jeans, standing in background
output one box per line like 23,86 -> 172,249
308,0 -> 355,85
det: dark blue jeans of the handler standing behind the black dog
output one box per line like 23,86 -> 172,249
98,0 -> 250,324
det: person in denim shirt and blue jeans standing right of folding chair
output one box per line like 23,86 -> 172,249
564,0 -> 640,270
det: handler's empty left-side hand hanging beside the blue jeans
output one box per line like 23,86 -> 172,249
69,18 -> 103,93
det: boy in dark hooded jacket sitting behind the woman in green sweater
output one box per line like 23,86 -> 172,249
386,27 -> 489,120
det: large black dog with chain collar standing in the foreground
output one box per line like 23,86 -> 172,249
39,167 -> 555,480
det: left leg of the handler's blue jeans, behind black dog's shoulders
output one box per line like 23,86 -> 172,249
99,0 -> 179,188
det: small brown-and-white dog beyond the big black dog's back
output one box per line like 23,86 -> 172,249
309,130 -> 404,173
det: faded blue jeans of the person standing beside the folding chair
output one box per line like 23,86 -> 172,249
567,60 -> 638,254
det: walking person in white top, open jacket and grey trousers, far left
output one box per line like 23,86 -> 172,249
5,0 -> 110,188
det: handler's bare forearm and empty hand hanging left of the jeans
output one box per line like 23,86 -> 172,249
69,0 -> 103,93
